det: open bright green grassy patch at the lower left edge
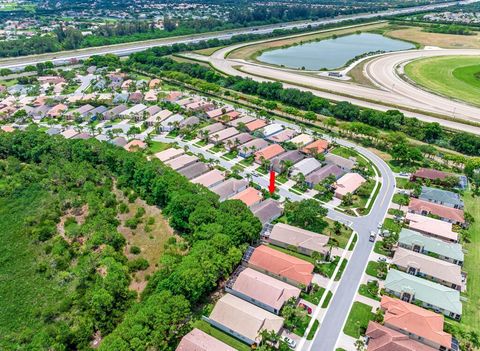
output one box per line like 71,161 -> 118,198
0,189 -> 68,349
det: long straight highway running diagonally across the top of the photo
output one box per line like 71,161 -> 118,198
0,0 -> 479,70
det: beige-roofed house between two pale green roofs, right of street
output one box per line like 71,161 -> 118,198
391,247 -> 464,291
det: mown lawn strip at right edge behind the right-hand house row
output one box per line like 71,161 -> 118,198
461,192 -> 480,330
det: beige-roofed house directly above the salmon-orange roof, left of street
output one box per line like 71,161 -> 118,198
268,223 -> 329,256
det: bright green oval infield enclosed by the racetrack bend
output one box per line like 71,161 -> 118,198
405,56 -> 480,106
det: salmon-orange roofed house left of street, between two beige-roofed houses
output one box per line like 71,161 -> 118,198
246,245 -> 315,289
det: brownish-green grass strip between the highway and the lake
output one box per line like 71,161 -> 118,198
228,22 -> 388,60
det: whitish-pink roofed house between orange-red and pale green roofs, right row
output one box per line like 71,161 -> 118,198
405,212 -> 458,243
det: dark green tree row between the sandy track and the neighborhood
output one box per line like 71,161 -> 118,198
126,51 -> 480,156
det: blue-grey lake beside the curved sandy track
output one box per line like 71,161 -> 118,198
257,33 -> 415,70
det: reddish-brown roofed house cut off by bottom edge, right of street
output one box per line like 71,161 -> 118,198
365,321 -> 435,351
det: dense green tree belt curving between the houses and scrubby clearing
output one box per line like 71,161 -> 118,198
0,131 -> 261,351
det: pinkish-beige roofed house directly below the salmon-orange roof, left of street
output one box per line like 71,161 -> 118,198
225,267 -> 301,314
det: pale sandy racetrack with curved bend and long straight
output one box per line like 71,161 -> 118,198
190,43 -> 480,134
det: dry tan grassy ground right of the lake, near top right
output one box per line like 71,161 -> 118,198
385,27 -> 480,49
